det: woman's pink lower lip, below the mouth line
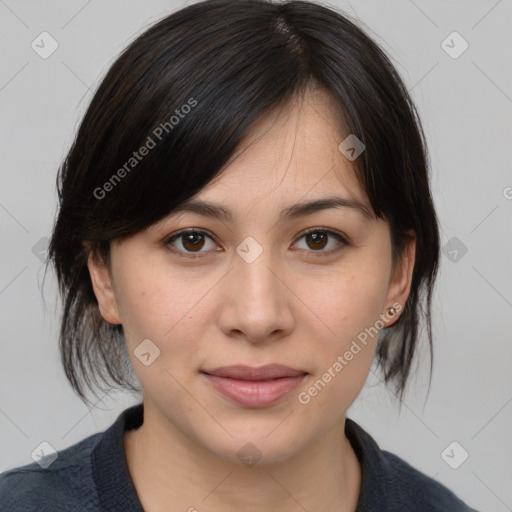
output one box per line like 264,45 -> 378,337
204,374 -> 306,407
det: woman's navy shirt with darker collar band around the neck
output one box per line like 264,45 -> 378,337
0,404 -> 477,512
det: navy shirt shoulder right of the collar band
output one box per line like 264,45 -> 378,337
381,450 -> 477,512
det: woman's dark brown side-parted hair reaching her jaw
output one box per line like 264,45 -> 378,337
49,0 -> 439,408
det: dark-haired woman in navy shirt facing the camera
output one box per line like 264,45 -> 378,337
0,0 -> 480,512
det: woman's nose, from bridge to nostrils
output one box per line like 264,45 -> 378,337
218,242 -> 295,343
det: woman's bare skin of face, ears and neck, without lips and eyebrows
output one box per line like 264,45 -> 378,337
89,90 -> 415,512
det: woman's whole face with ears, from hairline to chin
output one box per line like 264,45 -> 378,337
89,87 -> 414,462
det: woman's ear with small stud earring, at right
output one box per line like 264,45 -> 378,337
384,231 -> 416,327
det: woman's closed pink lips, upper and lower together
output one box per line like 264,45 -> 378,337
202,364 -> 307,407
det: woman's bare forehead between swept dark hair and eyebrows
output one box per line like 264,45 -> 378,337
200,89 -> 371,211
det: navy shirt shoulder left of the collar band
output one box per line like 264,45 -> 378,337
0,433 -> 102,512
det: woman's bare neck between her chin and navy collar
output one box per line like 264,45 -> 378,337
124,402 -> 361,512
